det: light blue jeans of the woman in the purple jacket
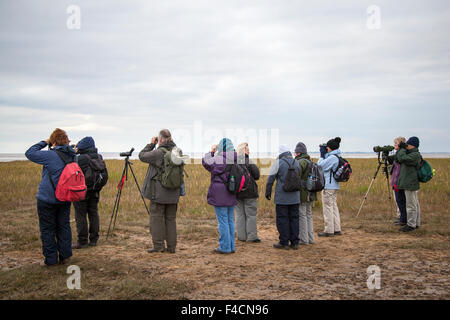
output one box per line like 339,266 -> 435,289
214,206 -> 236,252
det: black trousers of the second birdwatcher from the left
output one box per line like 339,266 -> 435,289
73,196 -> 100,245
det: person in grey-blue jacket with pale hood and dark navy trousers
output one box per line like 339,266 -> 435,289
265,145 -> 300,250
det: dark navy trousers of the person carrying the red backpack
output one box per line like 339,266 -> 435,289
37,200 -> 72,265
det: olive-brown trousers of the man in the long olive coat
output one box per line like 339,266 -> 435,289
150,201 -> 178,250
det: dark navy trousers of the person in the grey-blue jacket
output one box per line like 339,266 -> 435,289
276,204 -> 300,246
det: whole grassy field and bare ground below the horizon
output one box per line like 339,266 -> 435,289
0,159 -> 450,299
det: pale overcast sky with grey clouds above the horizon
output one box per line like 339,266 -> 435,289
0,0 -> 450,153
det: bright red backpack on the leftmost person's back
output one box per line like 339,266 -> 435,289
50,150 -> 87,202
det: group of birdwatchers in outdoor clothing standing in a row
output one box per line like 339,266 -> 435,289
25,128 -> 421,266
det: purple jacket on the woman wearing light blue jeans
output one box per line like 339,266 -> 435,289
202,151 -> 237,207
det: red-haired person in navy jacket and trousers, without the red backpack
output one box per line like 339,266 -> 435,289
25,128 -> 79,266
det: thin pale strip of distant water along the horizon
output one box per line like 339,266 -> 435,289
0,152 -> 450,162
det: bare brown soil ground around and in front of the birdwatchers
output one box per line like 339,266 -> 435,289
0,216 -> 450,299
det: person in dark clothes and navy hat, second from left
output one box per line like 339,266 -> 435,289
72,137 -> 108,249
